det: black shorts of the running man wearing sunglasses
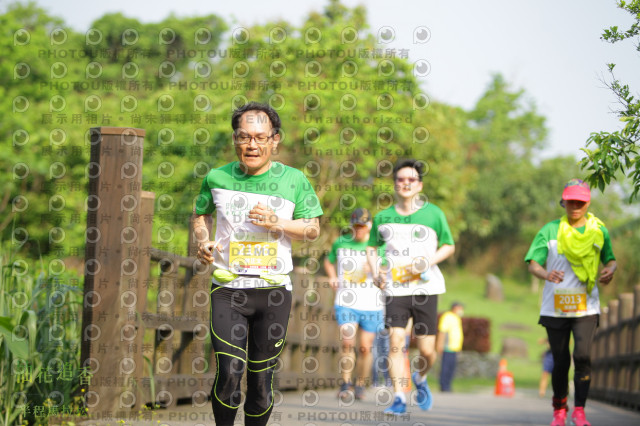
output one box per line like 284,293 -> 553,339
384,294 -> 438,336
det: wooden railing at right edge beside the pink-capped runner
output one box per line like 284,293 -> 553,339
589,285 -> 640,410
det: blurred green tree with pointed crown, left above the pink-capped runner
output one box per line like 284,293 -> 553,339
459,75 -> 548,262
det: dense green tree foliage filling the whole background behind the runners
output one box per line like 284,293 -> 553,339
0,1 -> 627,284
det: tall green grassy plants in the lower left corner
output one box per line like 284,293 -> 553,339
0,253 -> 84,426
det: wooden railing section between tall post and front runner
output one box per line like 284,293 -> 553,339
139,249 -> 215,406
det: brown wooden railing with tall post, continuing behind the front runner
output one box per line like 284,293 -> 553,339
81,127 -> 339,418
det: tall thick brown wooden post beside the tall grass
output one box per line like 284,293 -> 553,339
81,127 -> 145,419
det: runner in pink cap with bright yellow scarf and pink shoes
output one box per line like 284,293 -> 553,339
524,179 -> 617,426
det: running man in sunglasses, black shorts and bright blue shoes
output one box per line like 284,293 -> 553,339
367,160 -> 455,414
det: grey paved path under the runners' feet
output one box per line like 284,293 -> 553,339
80,389 -> 640,426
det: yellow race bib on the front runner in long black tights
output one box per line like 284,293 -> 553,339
229,233 -> 278,275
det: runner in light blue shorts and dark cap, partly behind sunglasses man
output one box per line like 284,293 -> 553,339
324,208 -> 383,401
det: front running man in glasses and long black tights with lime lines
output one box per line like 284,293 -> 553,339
194,102 -> 322,426
